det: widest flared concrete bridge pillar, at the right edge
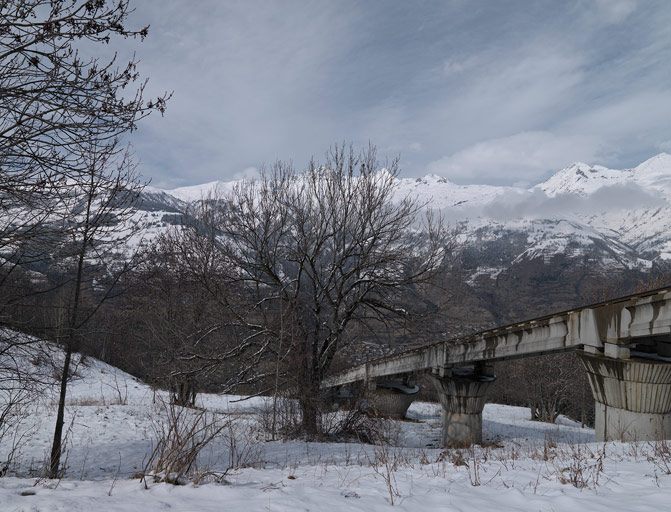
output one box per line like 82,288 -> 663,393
580,352 -> 671,441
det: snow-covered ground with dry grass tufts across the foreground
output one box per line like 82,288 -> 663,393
0,346 -> 671,512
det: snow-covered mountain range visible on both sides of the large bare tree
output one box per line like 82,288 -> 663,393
130,153 -> 671,277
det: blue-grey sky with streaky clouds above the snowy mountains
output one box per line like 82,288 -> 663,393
111,0 -> 671,188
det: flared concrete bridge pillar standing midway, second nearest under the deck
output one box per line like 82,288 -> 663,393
431,371 -> 496,448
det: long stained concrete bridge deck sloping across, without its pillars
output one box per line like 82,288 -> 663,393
322,287 -> 671,388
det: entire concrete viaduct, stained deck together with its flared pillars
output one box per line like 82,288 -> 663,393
322,288 -> 671,446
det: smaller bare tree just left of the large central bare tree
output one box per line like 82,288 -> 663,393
127,227 -> 235,406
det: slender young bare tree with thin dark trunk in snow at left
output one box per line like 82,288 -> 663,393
50,141 -> 143,478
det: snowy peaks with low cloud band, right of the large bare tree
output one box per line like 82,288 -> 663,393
410,153 -> 671,269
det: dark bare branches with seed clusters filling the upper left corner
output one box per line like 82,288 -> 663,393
0,0 -> 166,292
